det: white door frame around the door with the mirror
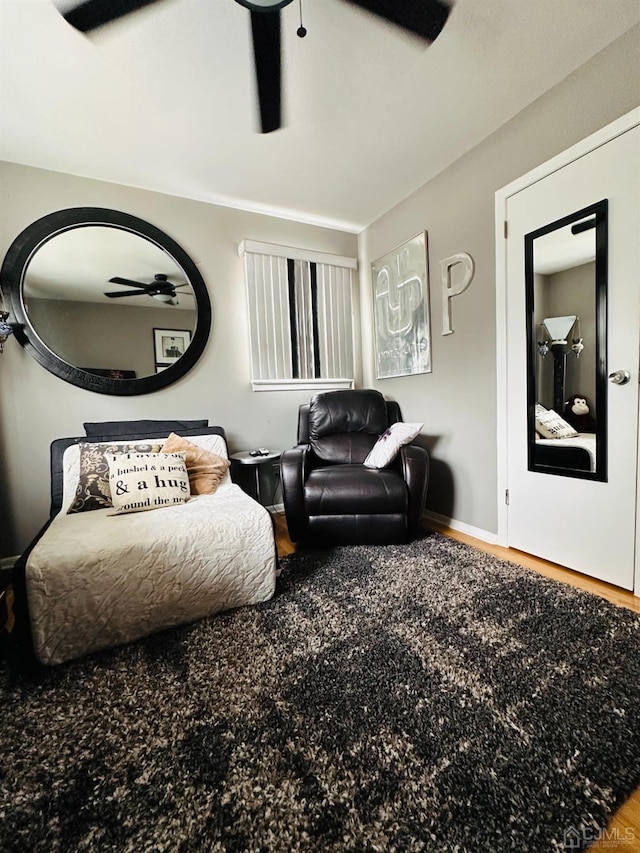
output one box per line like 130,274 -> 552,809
495,107 -> 640,595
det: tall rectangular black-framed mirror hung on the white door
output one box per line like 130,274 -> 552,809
525,199 -> 607,481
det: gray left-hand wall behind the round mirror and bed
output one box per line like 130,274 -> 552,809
0,169 -> 357,557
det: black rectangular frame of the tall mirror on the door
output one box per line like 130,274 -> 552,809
524,199 -> 609,483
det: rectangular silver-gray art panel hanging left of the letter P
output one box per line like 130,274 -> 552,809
371,231 -> 431,379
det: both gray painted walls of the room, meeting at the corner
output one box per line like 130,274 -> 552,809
0,27 -> 640,555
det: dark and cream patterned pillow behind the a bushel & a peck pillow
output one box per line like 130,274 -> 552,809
67,440 -> 163,513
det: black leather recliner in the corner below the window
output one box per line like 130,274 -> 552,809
280,390 -> 429,545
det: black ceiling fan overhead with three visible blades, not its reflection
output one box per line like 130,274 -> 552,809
59,0 -> 454,133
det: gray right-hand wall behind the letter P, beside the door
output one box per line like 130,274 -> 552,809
359,21 -> 640,534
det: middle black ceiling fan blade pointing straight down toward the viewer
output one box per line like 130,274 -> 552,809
251,9 -> 281,133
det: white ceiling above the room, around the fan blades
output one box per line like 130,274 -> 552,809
0,0 -> 640,232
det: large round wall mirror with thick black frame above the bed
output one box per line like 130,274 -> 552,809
0,207 -> 211,395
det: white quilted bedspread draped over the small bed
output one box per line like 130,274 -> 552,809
26,483 -> 276,664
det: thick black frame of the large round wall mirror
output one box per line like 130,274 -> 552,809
0,207 -> 211,396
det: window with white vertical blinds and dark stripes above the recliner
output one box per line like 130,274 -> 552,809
240,240 -> 356,391
